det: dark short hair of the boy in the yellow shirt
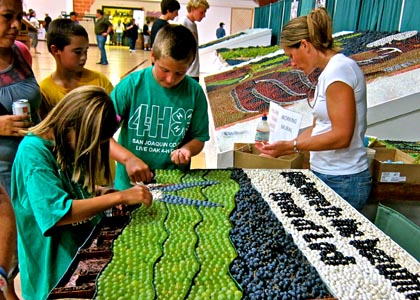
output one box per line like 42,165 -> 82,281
47,19 -> 89,53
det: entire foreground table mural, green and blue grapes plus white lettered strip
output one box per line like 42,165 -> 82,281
49,169 -> 420,300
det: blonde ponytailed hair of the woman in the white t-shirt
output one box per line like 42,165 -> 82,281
280,7 -> 340,52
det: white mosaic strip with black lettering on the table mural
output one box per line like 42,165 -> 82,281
244,170 -> 420,300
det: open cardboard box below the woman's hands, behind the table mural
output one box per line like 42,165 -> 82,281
233,143 -> 303,169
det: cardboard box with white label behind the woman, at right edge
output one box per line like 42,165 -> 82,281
372,147 -> 420,183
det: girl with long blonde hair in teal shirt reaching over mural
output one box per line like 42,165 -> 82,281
12,86 -> 152,300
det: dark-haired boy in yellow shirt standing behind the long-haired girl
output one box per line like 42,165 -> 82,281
40,19 -> 114,118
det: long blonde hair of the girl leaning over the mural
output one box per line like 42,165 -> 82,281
30,86 -> 118,193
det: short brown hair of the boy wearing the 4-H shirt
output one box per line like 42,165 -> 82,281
153,24 -> 197,63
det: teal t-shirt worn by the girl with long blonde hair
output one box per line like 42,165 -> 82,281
11,134 -> 99,300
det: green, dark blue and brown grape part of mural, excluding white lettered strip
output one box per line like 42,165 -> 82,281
46,170 -> 330,300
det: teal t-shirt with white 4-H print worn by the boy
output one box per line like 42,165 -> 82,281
111,67 -> 209,189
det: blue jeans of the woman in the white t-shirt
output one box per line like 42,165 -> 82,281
312,169 -> 372,210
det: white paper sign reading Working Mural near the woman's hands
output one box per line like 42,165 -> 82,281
268,102 -> 302,143
